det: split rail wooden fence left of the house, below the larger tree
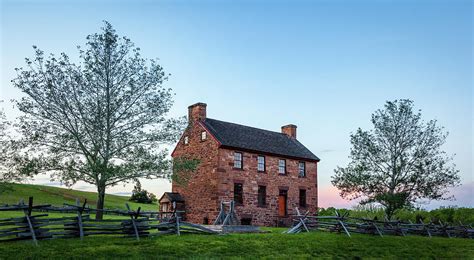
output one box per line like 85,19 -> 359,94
0,197 -> 217,245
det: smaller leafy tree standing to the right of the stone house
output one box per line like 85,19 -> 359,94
332,99 -> 460,218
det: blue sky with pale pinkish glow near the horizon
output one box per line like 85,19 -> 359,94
0,0 -> 474,207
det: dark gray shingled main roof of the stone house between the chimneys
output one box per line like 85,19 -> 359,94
202,118 -> 319,161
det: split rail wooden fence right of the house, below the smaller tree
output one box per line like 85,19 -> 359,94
284,208 -> 474,239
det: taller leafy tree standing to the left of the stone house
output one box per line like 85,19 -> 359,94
12,22 -> 186,219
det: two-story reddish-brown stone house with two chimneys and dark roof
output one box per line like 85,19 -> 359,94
165,103 -> 319,226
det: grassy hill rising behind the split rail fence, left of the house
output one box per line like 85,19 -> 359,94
0,184 -> 158,211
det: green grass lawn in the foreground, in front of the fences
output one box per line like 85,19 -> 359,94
0,229 -> 474,259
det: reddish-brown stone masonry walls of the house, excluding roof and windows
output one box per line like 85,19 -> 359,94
172,103 -> 318,226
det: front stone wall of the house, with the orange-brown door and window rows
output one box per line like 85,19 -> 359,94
217,149 -> 318,226
